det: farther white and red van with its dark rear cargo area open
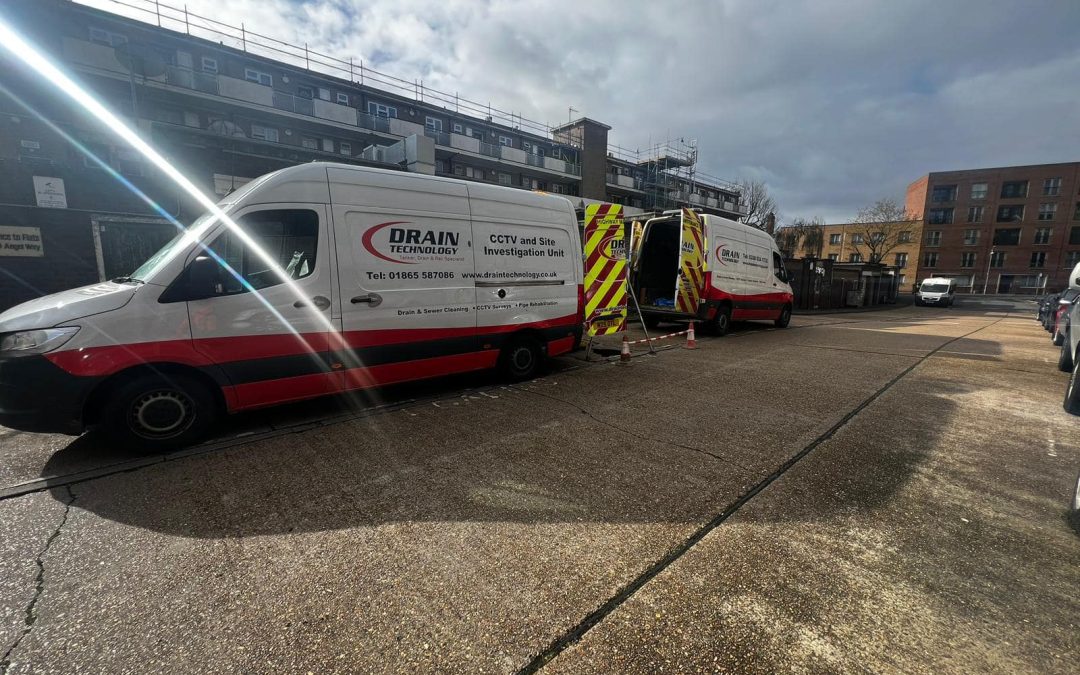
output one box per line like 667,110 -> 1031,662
630,212 -> 793,335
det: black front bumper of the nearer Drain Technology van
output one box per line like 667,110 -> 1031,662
0,354 -> 100,436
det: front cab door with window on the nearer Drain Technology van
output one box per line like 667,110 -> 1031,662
188,204 -> 338,408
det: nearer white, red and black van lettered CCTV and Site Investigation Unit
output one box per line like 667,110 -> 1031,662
0,163 -> 583,447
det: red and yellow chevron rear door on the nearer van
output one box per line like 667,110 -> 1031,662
585,204 -> 626,336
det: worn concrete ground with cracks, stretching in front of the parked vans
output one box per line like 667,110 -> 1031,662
0,298 -> 1080,673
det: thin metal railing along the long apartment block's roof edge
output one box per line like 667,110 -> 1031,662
72,0 -> 552,139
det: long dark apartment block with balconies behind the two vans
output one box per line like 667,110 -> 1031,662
0,0 -> 745,310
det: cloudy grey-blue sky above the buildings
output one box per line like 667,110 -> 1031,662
80,0 -> 1080,221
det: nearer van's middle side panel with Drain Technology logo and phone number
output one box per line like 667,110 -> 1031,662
327,167 -> 477,389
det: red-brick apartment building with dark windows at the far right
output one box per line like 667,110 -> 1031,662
906,162 -> 1080,294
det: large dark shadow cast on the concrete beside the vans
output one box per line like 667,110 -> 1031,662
46,334 -> 1002,539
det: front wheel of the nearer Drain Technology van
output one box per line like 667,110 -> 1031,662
100,374 -> 218,453
